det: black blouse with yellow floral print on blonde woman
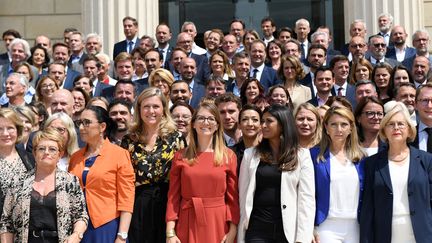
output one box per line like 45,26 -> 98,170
121,131 -> 186,186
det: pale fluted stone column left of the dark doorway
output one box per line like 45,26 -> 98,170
81,0 -> 159,57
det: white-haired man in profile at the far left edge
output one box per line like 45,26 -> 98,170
2,73 -> 31,107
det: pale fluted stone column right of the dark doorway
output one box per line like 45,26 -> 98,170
344,0 -> 425,46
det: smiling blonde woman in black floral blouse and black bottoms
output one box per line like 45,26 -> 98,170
121,87 -> 185,243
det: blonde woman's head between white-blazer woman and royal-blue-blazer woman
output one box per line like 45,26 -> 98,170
294,103 -> 322,149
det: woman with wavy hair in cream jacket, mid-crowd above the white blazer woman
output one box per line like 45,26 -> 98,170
278,56 -> 312,108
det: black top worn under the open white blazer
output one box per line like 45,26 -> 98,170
251,161 -> 282,223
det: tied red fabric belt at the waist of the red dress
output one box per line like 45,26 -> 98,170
181,196 -> 226,226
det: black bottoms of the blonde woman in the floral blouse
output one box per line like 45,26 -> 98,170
128,183 -> 168,243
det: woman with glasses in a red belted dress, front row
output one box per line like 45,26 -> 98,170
166,102 -> 240,243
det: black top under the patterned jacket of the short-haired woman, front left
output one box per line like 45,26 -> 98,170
29,189 -> 58,243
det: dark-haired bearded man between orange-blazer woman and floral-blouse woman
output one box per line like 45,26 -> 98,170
108,99 -> 132,145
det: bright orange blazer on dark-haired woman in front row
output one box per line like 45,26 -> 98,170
69,139 -> 135,228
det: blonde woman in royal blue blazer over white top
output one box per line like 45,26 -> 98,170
310,107 -> 364,243
